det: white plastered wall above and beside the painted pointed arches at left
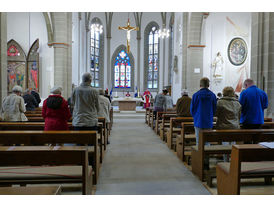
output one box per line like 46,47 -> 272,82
7,12 -> 54,98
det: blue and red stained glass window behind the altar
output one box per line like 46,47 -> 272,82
114,50 -> 131,88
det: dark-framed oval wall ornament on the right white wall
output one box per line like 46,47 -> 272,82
227,37 -> 247,66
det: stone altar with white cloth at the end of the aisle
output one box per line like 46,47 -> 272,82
112,97 -> 143,111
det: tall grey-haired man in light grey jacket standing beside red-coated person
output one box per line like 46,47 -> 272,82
71,72 -> 99,130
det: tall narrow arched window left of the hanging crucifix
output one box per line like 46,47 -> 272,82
90,18 -> 103,87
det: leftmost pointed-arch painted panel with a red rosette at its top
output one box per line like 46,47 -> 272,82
7,39 -> 27,94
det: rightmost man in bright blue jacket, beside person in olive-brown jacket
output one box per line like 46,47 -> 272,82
239,79 -> 268,129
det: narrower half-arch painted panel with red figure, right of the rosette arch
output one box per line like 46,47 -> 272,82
27,39 -> 39,91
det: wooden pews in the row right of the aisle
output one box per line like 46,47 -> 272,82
145,108 -> 274,194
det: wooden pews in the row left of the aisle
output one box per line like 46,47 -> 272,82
0,106 -> 113,194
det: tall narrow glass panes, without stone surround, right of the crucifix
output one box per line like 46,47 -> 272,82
147,26 -> 159,89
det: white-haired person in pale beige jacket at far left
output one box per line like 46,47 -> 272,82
1,85 -> 28,122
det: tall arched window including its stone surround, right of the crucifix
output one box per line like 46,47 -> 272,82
144,22 -> 159,91
